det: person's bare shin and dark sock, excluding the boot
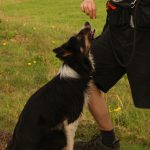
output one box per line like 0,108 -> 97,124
88,84 -> 117,147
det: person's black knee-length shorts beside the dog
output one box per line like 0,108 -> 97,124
92,0 -> 150,108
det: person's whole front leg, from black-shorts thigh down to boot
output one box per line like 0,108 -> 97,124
74,25 -> 125,150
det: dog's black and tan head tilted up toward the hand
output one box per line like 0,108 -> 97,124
54,22 -> 95,61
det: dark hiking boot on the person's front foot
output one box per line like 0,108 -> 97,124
74,135 -> 120,150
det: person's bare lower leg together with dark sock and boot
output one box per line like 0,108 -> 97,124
74,83 -> 120,150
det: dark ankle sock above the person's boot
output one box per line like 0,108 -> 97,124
101,130 -> 116,147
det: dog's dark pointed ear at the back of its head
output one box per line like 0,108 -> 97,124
53,47 -> 72,59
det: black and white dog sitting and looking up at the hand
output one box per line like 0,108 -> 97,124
7,22 -> 94,150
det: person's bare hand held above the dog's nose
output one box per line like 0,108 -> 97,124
81,0 -> 96,19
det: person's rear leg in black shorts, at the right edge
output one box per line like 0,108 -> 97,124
126,0 -> 150,109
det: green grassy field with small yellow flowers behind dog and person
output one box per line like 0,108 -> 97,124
0,0 -> 150,150
